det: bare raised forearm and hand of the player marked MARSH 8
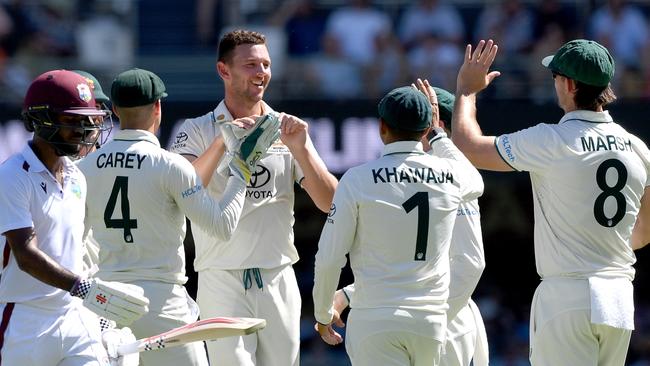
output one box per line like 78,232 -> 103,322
451,40 -> 512,171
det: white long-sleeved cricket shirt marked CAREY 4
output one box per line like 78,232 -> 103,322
79,130 -> 245,284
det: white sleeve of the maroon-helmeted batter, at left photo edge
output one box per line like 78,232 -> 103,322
0,174 -> 34,234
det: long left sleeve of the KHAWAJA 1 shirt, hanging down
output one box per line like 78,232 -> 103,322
313,172 -> 358,324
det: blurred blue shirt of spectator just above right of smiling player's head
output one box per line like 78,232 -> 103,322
325,0 -> 392,66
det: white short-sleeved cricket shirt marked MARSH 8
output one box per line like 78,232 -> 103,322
495,111 -> 650,280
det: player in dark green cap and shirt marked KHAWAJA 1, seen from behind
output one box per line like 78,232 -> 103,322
313,86 -> 483,366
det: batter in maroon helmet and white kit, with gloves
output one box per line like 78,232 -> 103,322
0,70 -> 148,366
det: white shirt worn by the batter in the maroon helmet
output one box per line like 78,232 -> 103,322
0,145 -> 86,310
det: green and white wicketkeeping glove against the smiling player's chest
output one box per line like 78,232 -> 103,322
222,113 -> 280,184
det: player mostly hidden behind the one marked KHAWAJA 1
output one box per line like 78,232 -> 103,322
323,83 -> 488,366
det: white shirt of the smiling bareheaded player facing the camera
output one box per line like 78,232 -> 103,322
171,101 -> 303,271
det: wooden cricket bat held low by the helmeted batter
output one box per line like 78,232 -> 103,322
117,317 -> 266,355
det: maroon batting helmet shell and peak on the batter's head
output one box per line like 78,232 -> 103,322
23,70 -> 106,116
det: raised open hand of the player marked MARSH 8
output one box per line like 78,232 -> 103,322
456,40 -> 501,95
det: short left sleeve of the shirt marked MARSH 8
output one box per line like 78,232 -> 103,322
494,123 -> 566,172
